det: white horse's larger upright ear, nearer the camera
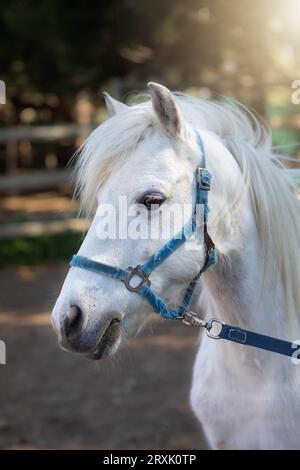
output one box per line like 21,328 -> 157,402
148,82 -> 184,137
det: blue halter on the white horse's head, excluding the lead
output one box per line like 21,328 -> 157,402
70,134 -> 217,320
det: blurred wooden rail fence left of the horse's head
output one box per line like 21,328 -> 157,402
0,124 -> 92,239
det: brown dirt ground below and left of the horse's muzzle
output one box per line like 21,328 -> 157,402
0,266 -> 206,450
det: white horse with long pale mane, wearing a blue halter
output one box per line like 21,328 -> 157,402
52,83 -> 300,449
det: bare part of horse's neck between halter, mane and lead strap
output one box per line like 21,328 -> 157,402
199,197 -> 288,337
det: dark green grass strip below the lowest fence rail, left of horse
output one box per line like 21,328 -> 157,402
0,232 -> 83,268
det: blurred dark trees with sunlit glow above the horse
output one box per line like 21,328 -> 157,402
0,0 -> 299,122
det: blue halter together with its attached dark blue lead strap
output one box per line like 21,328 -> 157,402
70,133 -> 300,360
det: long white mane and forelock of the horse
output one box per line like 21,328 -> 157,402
75,94 -> 300,319
